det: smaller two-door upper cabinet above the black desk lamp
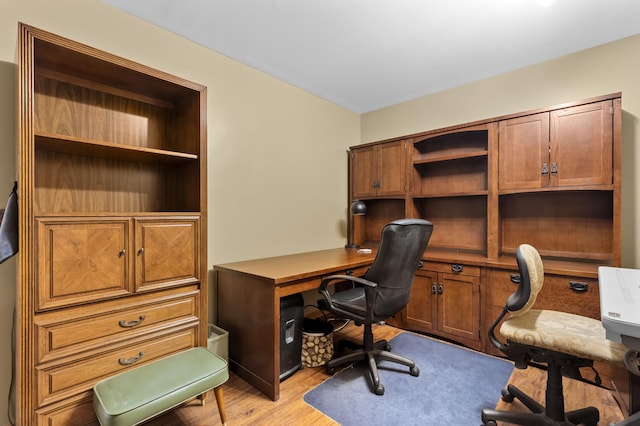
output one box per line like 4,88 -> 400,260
351,141 -> 407,199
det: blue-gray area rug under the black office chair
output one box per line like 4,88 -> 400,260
304,332 -> 513,426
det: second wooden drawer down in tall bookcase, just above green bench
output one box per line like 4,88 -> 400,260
35,323 -> 198,406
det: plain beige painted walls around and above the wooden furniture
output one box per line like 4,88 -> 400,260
0,0 -> 640,426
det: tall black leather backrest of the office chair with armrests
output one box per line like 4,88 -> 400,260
364,219 -> 433,317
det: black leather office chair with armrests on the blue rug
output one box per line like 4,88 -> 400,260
318,219 -> 433,395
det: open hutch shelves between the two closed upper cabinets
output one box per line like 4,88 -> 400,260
411,125 -> 489,255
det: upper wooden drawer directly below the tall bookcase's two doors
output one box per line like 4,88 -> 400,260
35,288 -> 199,363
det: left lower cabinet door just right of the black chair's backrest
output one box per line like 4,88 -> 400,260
403,270 -> 438,331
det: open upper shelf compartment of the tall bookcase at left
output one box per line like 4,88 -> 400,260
33,38 -> 203,214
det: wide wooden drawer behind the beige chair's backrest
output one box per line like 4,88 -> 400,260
491,269 -> 600,319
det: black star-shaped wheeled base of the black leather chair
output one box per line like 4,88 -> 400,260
327,331 -> 420,395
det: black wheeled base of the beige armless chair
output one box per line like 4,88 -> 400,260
482,385 -> 600,426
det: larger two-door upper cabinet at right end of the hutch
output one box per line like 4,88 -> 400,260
498,100 -> 613,191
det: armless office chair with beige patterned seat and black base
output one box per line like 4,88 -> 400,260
482,244 -> 627,426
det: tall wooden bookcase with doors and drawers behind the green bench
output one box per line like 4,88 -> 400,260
15,24 -> 207,425
